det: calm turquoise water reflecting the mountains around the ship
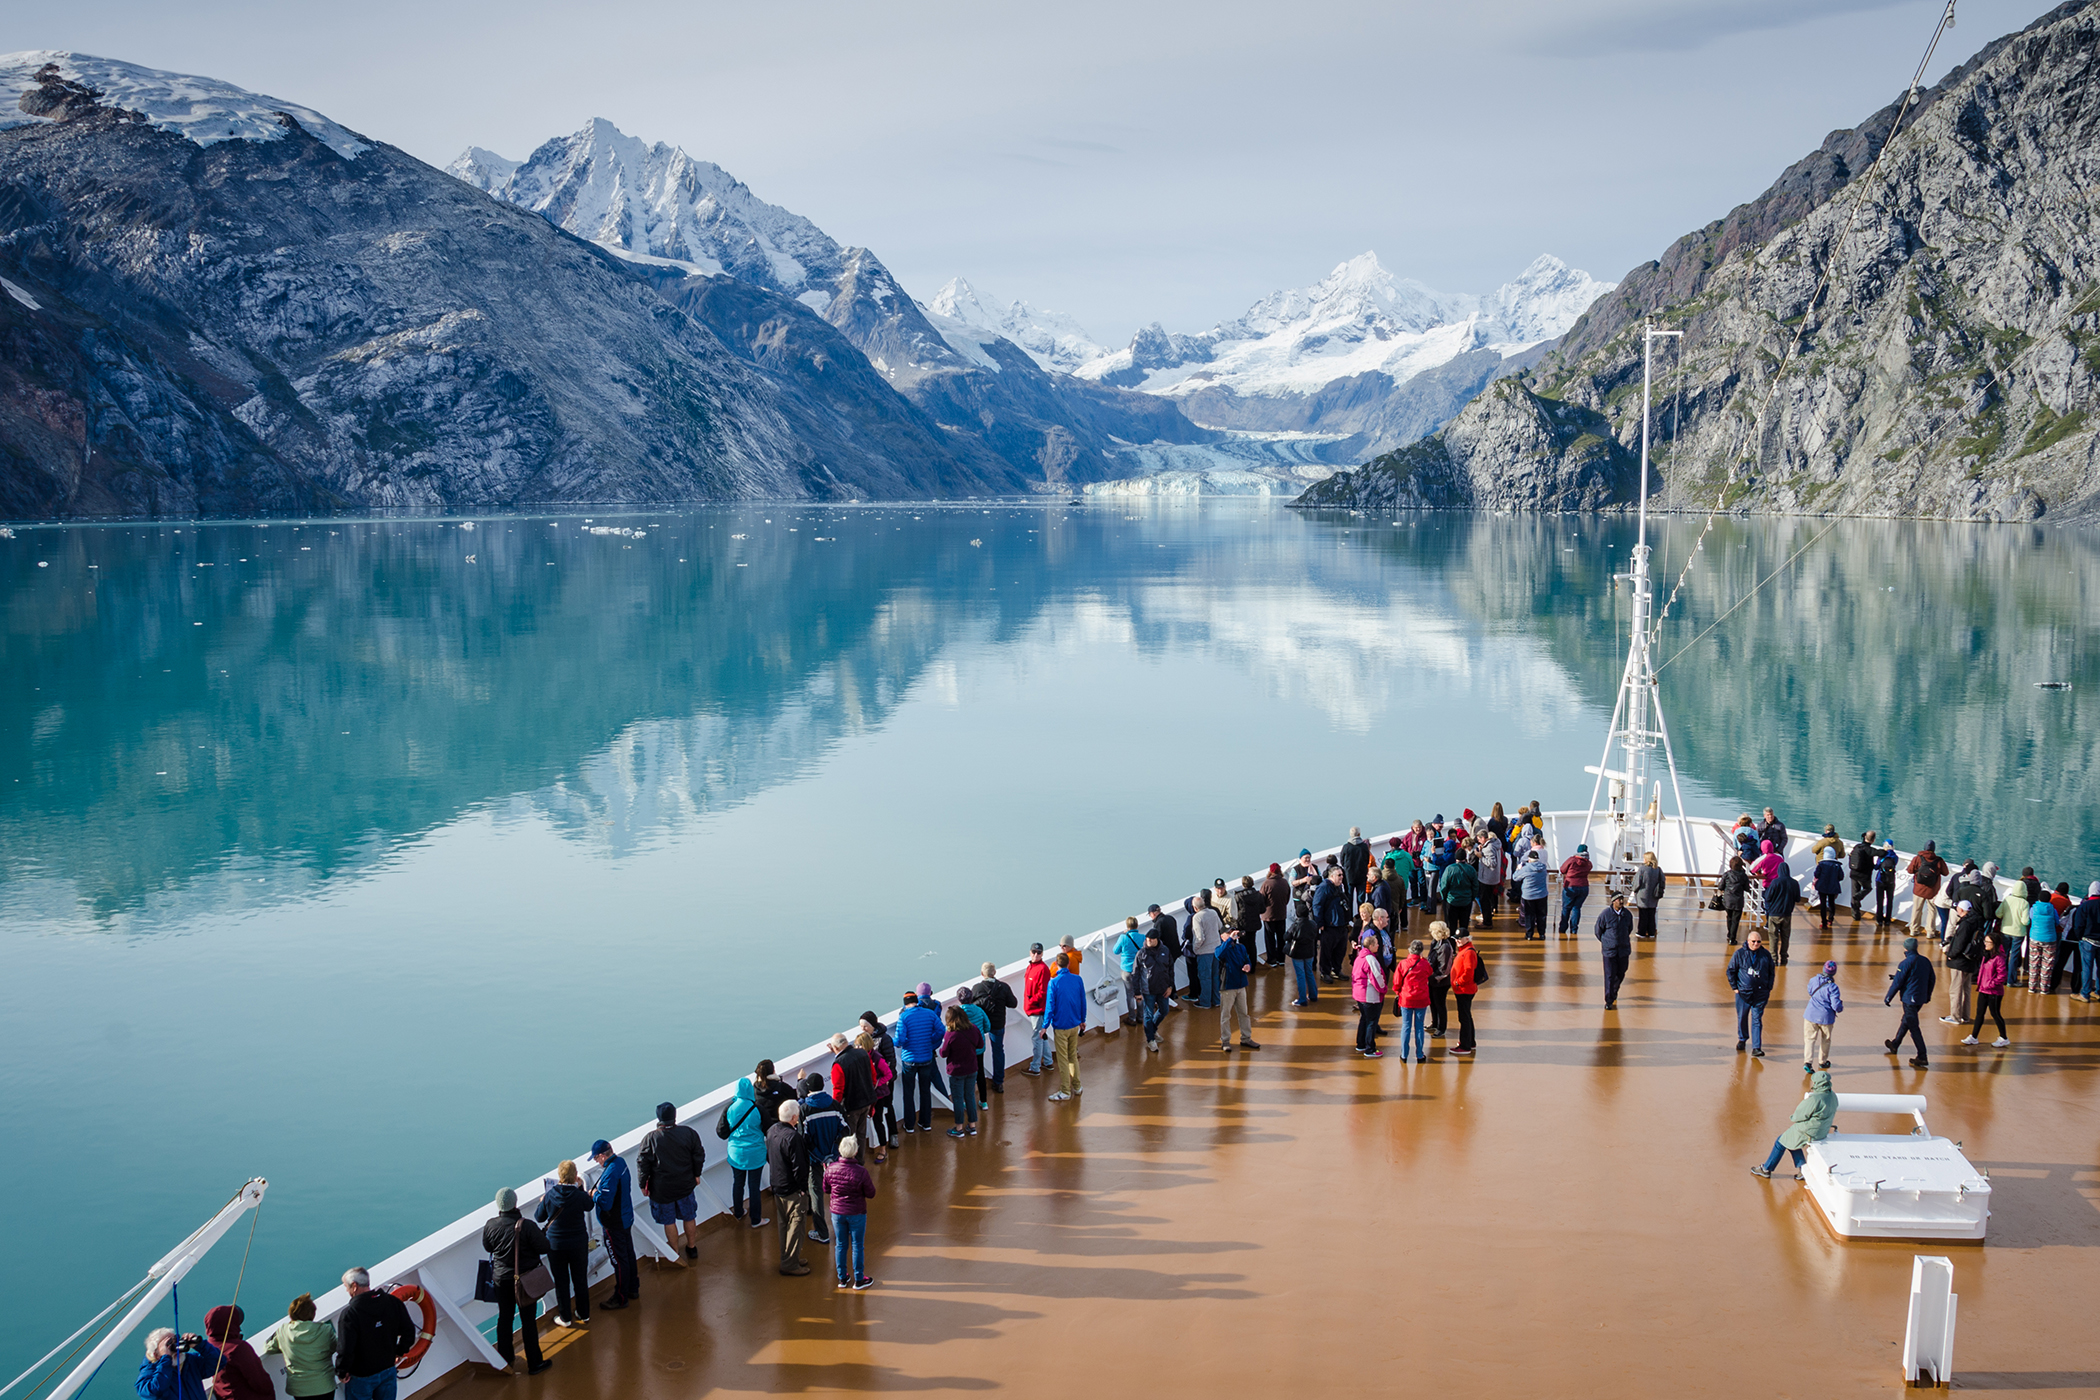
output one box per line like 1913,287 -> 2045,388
0,502 -> 2100,1394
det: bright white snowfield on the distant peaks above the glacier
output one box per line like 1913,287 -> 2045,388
1075,252 -> 1613,397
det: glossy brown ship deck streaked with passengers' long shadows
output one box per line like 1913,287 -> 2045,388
452,888 -> 2100,1400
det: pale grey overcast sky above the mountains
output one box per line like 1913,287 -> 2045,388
0,0 -> 2045,344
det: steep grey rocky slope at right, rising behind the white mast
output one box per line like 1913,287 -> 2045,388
1302,0 -> 2100,521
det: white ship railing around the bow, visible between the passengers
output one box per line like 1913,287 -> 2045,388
250,812 -> 1948,1396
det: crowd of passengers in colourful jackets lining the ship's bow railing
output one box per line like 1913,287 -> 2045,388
155,802 -> 2100,1400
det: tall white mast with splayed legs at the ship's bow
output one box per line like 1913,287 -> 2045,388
1581,323 -> 1697,886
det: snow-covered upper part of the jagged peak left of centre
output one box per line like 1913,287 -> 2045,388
445,118 -> 844,293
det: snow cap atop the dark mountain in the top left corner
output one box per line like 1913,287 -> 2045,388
0,48 -> 372,160
